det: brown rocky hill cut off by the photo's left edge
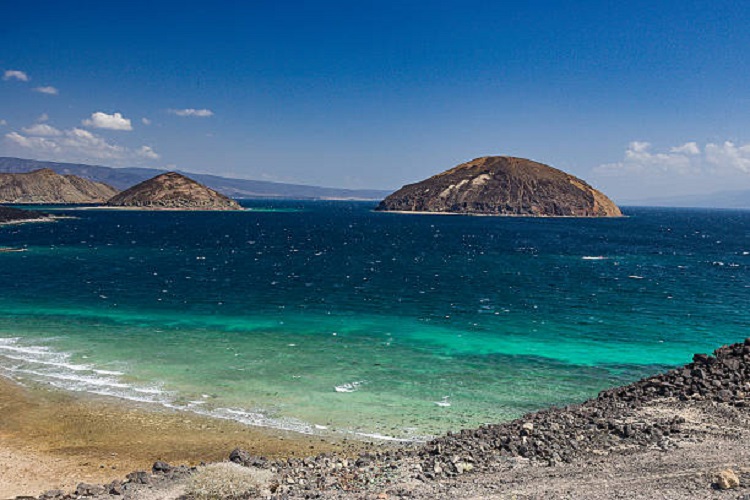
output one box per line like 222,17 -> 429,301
0,168 -> 117,204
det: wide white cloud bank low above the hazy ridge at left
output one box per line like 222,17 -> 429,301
5,124 -> 159,163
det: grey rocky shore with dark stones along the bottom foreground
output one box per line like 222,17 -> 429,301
11,339 -> 750,499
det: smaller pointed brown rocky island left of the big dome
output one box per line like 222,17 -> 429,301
107,172 -> 242,210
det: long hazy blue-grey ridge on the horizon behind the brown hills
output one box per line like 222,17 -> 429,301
0,157 -> 388,200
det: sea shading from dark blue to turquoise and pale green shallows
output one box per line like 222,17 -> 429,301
0,200 -> 750,441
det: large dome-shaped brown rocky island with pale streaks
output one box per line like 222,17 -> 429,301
377,156 -> 622,217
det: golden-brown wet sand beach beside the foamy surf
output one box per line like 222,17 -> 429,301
0,377 -> 364,499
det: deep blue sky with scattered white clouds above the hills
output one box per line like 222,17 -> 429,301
0,0 -> 750,200
